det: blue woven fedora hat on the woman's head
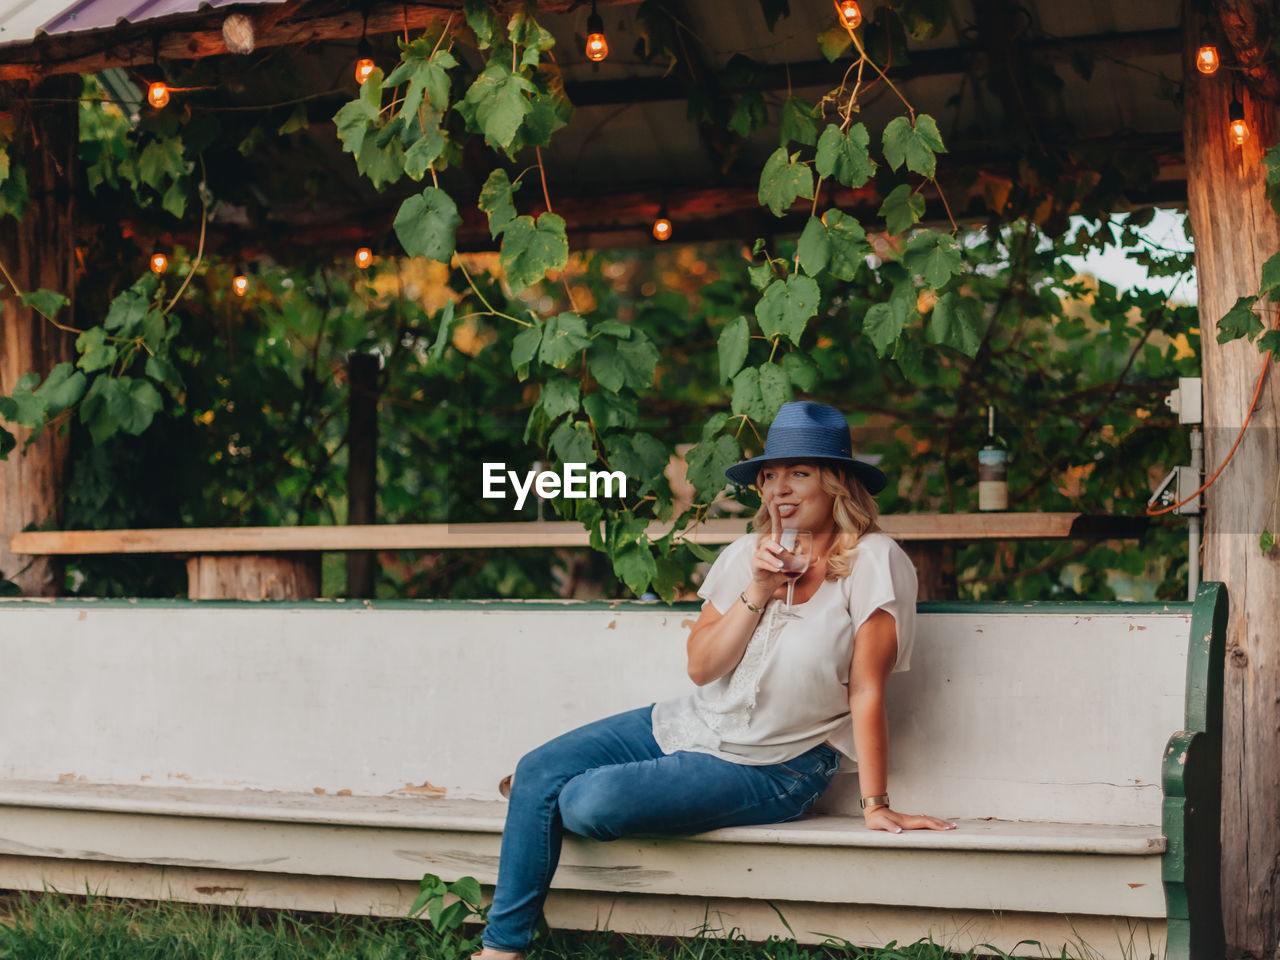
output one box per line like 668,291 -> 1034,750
724,401 -> 888,494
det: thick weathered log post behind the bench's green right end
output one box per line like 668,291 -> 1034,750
1183,0 -> 1280,960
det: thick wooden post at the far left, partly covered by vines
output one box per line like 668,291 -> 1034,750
0,77 -> 81,596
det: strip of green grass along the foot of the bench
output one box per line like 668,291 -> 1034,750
0,892 -> 1141,960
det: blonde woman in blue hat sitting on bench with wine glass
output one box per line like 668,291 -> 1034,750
475,402 -> 955,960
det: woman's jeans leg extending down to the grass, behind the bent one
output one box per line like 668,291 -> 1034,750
483,704 -> 662,951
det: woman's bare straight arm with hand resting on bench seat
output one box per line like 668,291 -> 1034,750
849,609 -> 955,833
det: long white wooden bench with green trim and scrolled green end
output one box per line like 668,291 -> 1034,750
0,585 -> 1226,960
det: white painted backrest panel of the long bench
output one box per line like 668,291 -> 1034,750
0,600 -> 1192,823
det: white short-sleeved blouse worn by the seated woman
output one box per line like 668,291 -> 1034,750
653,532 -> 915,764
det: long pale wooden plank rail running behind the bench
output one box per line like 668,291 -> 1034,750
9,513 -> 1146,556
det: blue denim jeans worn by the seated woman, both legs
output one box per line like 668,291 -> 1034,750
483,704 -> 840,951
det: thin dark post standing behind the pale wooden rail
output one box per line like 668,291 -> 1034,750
347,353 -> 379,596
